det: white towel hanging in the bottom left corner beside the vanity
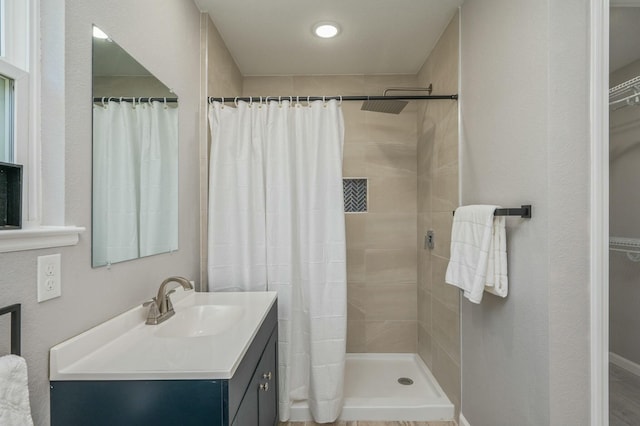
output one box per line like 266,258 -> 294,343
0,355 -> 33,426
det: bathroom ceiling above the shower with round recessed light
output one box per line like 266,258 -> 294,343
194,0 -> 463,76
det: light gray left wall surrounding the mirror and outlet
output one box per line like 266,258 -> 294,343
0,0 -> 200,425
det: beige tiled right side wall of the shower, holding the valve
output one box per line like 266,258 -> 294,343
417,15 -> 460,411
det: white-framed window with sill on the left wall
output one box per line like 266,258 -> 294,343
0,0 -> 84,253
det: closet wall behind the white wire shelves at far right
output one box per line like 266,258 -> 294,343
609,61 -> 640,364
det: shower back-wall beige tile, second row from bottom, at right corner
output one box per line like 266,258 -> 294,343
365,282 -> 418,321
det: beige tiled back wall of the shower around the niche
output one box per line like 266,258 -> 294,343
243,75 -> 417,352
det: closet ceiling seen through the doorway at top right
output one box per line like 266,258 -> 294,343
609,7 -> 640,71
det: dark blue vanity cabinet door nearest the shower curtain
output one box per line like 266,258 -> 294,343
256,331 -> 278,426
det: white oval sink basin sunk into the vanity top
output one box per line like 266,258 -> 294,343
154,305 -> 244,337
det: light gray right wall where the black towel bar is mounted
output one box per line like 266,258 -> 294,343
460,0 -> 589,426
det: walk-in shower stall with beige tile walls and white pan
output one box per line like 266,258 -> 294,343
235,16 -> 460,421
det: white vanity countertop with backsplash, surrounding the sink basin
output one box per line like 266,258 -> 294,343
49,290 -> 276,380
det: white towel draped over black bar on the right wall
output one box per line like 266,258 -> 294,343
445,205 -> 509,303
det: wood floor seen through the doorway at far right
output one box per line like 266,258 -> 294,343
609,364 -> 640,426
